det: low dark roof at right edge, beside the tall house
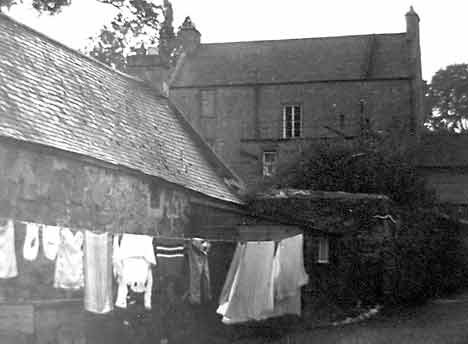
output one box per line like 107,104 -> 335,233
418,133 -> 468,168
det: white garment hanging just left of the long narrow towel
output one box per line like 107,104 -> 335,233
54,228 -> 84,290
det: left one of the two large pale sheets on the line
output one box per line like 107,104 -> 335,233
217,241 -> 275,324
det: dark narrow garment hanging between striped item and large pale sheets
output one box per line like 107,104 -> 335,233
188,238 -> 211,304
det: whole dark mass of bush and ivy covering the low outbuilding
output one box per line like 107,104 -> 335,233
250,138 -> 468,307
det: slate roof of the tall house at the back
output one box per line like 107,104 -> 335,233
172,33 -> 409,87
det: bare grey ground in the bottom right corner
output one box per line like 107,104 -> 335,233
239,292 -> 468,344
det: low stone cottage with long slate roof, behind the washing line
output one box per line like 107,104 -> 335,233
0,14 -> 300,343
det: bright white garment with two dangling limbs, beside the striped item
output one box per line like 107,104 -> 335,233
113,234 -> 156,309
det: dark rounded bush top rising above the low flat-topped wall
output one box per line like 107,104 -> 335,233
263,139 -> 433,207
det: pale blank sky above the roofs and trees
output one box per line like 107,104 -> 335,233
4,0 -> 468,81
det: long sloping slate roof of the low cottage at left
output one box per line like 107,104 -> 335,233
0,14 -> 242,203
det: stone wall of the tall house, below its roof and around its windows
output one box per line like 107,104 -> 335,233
171,80 -> 412,184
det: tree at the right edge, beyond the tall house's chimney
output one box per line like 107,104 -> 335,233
426,64 -> 468,133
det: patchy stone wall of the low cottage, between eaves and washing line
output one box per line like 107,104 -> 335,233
0,140 -> 189,235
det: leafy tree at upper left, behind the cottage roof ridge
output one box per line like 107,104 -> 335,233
0,0 -> 175,71
